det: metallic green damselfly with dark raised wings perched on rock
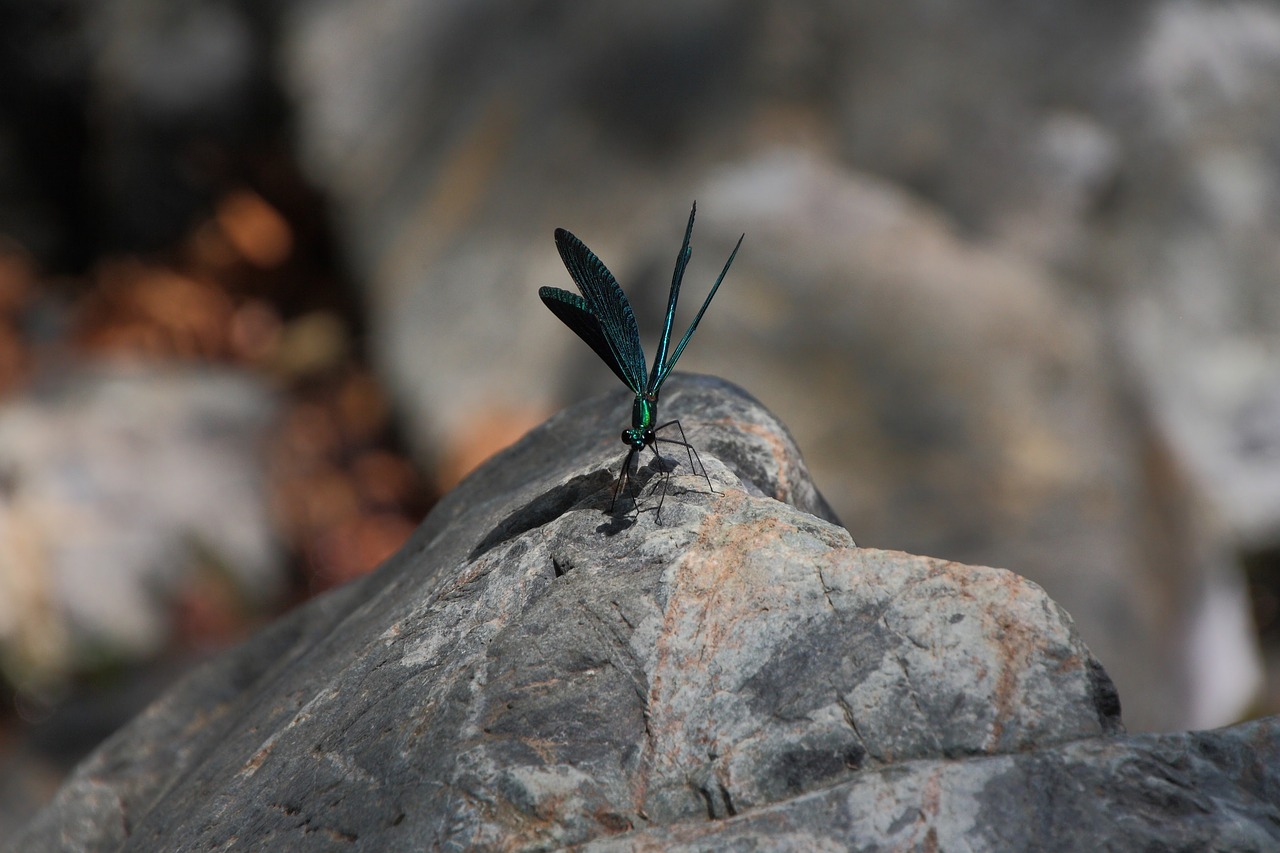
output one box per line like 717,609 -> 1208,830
538,201 -> 746,524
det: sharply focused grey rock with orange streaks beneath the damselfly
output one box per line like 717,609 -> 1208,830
20,377 -> 1280,852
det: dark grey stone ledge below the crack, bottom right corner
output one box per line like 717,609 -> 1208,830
584,717 -> 1280,853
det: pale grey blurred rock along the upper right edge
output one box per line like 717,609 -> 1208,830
1112,3 -> 1280,547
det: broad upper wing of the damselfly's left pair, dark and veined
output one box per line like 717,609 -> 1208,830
552,228 -> 648,394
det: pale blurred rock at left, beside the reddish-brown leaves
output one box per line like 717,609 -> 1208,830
0,362 -> 283,692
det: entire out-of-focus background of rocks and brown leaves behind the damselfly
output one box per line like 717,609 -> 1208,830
0,0 -> 1280,834
